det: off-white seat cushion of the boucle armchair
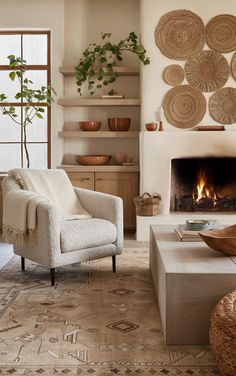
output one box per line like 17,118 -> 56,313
60,218 -> 117,253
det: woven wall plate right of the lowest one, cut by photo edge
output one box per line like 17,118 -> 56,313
209,87 -> 236,124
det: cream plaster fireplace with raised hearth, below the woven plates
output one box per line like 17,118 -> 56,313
136,131 -> 236,240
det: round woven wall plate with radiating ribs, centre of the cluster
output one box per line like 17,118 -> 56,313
185,51 -> 230,92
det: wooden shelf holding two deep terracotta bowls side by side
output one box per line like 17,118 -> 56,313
58,131 -> 139,138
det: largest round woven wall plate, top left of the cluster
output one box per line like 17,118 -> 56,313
155,9 -> 205,60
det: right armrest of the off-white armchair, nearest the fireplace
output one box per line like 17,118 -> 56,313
74,187 -> 123,249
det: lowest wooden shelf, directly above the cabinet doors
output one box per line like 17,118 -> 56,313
57,165 -> 139,172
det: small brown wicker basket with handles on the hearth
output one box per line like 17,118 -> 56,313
134,192 -> 161,216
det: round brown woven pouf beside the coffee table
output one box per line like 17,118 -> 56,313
210,290 -> 236,376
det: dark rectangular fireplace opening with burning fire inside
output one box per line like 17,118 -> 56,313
170,158 -> 236,212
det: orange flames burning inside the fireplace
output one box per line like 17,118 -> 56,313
192,168 -> 217,205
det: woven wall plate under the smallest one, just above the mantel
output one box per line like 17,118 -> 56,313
163,85 -> 206,128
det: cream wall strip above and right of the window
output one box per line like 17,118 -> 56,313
0,0 -> 64,167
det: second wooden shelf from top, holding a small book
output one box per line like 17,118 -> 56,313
58,99 -> 141,107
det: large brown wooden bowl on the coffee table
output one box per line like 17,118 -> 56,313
199,225 -> 236,255
